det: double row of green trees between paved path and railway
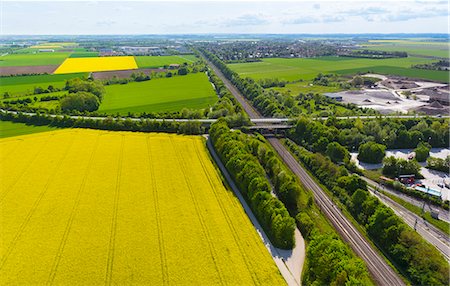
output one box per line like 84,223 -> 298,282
210,120 -> 372,285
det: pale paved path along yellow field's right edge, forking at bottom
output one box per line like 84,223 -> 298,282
206,136 -> 305,286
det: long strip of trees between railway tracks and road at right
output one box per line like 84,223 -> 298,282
286,141 -> 449,285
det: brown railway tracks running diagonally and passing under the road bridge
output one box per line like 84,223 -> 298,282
203,52 -> 405,286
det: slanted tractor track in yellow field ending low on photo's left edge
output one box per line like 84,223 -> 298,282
0,135 -> 75,270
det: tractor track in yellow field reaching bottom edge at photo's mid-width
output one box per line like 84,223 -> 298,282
170,137 -> 225,285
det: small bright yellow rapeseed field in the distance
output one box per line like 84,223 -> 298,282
54,56 -> 138,74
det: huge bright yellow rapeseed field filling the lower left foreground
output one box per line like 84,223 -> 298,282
0,129 -> 285,285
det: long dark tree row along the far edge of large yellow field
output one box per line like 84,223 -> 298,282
0,110 -> 205,135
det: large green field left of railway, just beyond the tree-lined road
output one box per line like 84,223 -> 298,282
99,73 -> 217,115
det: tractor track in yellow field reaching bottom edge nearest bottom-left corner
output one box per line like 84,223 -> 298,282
46,135 -> 100,285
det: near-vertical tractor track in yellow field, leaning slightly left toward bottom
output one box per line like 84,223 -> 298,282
105,135 -> 125,285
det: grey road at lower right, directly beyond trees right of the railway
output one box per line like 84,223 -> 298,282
369,187 -> 450,261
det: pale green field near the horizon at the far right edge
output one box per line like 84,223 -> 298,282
362,40 -> 450,58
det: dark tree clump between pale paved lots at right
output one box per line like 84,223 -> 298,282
382,156 -> 423,178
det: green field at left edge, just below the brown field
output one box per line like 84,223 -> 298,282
0,73 -> 87,96
